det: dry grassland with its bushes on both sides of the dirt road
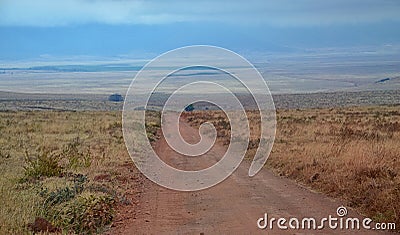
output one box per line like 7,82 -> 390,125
0,105 -> 400,234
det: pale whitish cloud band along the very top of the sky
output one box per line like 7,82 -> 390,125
0,0 -> 400,26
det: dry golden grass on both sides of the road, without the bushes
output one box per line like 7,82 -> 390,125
0,106 -> 400,234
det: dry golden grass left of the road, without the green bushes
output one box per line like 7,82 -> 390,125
0,111 -> 130,234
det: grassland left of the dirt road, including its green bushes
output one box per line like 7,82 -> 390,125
0,111 -> 132,234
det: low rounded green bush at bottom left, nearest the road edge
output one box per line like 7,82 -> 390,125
38,174 -> 115,234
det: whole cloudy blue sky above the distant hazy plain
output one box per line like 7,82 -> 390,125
0,0 -> 400,60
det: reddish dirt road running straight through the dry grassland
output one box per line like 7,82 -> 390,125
109,116 -> 382,234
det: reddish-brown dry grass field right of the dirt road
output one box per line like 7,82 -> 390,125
186,106 -> 400,228
